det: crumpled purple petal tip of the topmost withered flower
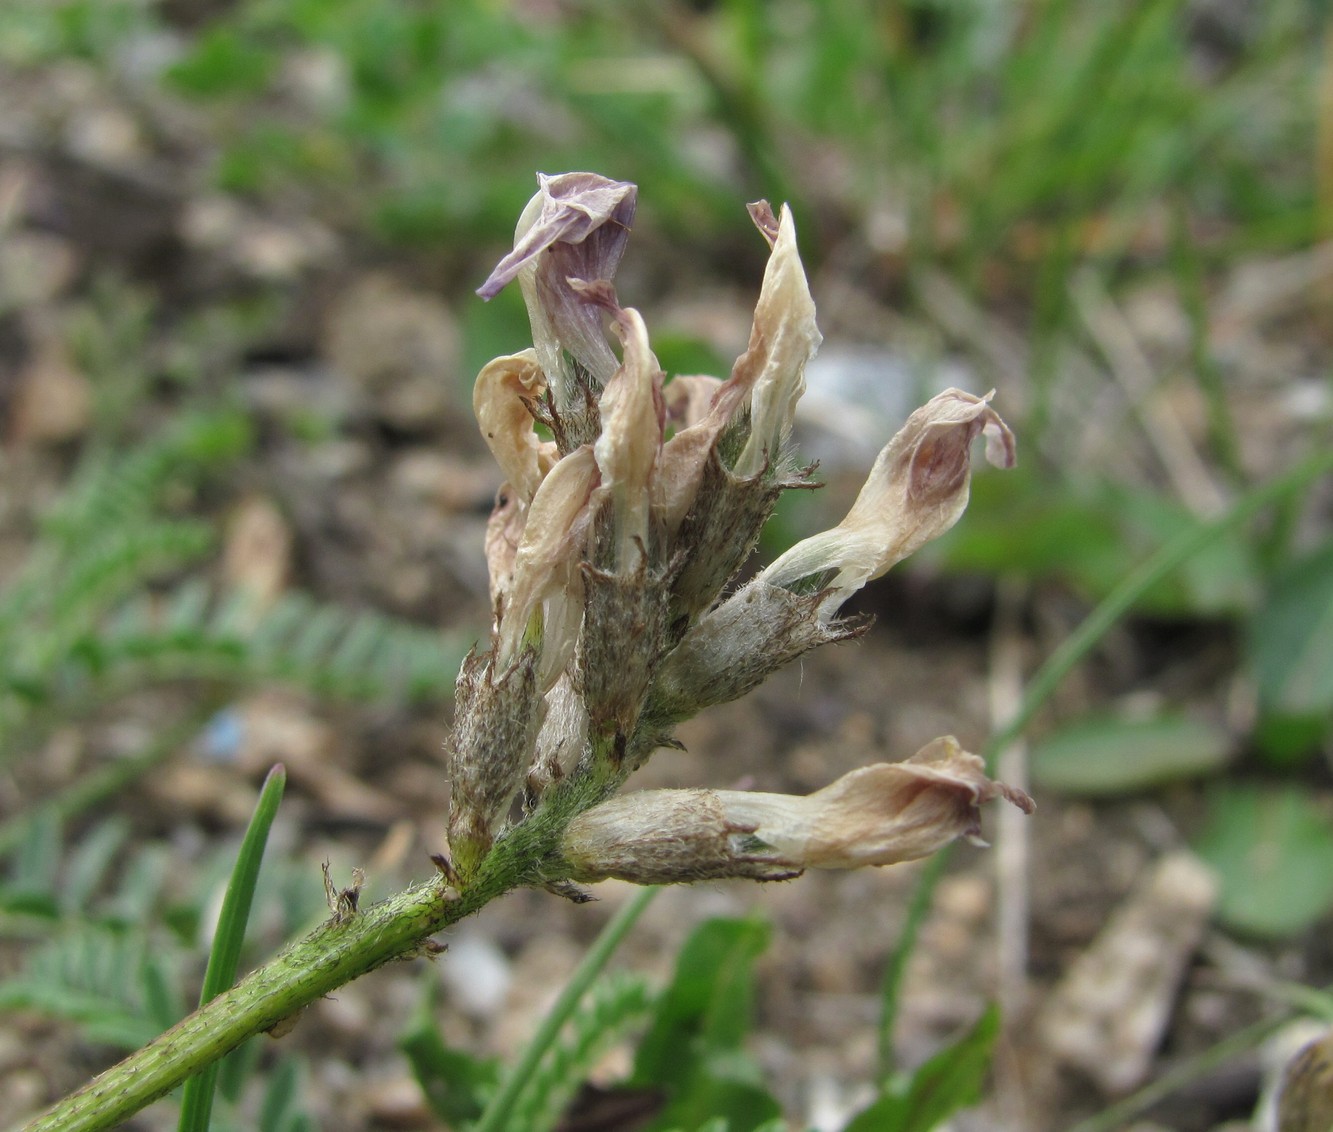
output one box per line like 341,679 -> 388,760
477,173 -> 639,299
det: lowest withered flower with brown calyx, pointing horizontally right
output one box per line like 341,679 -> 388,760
561,736 -> 1034,884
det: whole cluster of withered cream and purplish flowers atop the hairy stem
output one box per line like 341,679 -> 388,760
449,173 -> 1032,885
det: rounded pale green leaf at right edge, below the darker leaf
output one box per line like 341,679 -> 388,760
1196,785 -> 1333,937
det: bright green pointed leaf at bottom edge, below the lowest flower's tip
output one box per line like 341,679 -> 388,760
844,1005 -> 1000,1132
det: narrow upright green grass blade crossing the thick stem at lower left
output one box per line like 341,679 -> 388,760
177,763 -> 287,1132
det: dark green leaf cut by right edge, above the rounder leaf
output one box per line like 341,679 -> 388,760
1248,539 -> 1333,759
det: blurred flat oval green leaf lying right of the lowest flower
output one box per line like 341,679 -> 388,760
1032,715 -> 1232,797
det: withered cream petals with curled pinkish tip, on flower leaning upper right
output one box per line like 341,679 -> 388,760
760,389 -> 1014,620
